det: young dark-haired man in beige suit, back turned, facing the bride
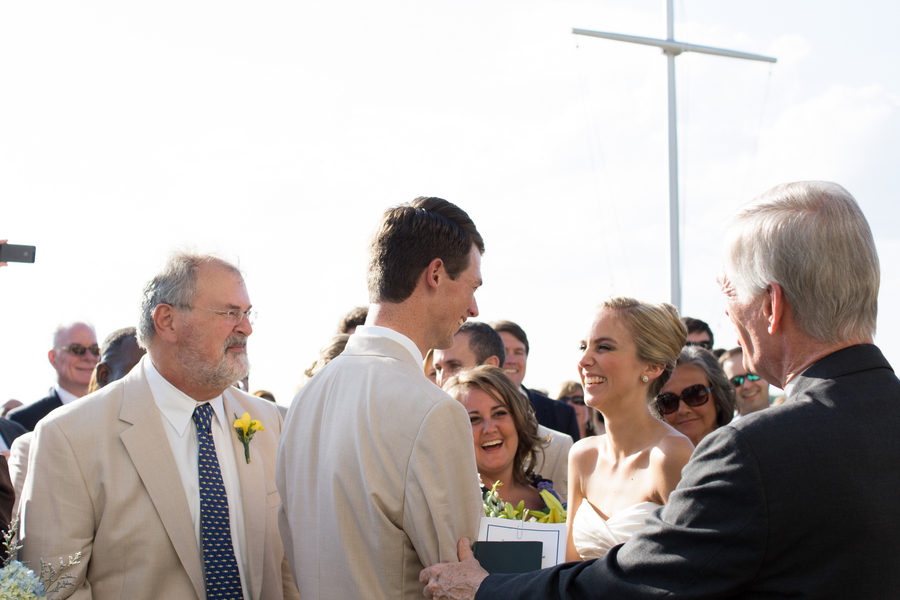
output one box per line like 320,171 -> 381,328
277,198 -> 484,600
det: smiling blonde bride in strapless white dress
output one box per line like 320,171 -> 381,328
566,298 -> 694,561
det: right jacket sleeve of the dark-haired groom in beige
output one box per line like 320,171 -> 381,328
403,398 -> 483,567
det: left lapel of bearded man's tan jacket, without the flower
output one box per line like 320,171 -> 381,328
119,369 -> 206,600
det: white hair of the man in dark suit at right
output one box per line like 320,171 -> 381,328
725,181 -> 881,343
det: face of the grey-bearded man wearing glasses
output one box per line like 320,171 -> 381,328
178,265 -> 253,393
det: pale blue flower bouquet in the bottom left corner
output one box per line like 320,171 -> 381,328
0,517 -> 81,600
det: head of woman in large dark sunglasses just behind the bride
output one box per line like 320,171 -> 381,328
651,346 -> 734,446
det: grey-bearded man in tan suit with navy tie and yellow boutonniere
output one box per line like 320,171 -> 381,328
20,253 -> 299,600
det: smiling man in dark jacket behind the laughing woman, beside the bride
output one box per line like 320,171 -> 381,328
491,321 -> 580,442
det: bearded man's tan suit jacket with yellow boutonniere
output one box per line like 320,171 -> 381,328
19,360 -> 299,600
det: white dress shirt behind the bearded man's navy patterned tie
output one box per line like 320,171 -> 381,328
141,355 -> 250,600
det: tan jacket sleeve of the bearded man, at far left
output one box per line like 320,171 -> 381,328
19,421 -> 94,600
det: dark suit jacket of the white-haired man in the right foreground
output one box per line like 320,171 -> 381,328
477,345 -> 900,600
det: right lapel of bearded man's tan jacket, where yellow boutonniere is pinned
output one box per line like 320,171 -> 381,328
222,390 -> 266,600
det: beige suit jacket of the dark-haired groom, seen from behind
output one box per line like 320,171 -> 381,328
276,333 -> 484,600
